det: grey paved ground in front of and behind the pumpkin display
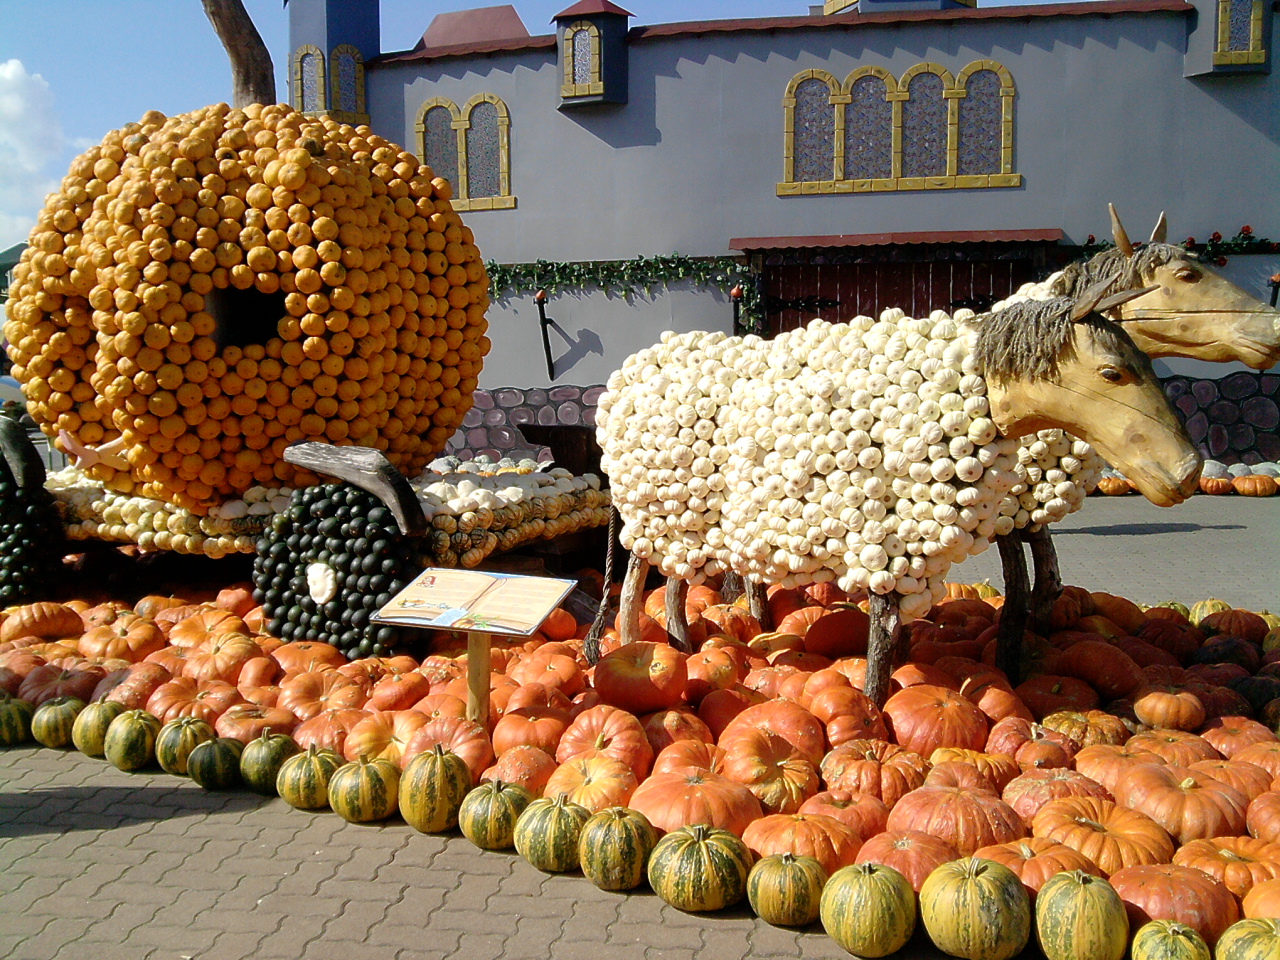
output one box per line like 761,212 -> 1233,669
0,497 -> 1280,960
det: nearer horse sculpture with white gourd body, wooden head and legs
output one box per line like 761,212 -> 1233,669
596,280 -> 1201,703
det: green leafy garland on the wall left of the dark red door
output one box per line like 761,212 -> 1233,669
485,253 -> 765,334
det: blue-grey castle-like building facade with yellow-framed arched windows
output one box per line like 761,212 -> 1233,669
289,0 -> 1280,463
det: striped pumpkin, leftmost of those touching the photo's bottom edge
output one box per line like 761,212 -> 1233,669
819,863 -> 915,956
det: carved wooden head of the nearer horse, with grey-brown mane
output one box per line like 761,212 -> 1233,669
974,280 -> 1202,507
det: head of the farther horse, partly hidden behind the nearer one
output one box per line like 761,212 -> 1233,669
1069,206 -> 1280,370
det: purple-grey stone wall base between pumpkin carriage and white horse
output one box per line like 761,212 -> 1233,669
445,384 -> 604,462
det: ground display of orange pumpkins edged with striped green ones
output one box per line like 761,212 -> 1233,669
0,575 -> 1280,960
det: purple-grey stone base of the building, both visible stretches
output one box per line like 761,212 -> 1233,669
447,372 -> 1280,465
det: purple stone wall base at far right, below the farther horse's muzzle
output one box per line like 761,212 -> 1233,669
1165,372 -> 1280,465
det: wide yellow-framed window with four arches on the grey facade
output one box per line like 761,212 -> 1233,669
777,60 -> 1021,197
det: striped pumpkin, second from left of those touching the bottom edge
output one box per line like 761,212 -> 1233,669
920,856 -> 1032,960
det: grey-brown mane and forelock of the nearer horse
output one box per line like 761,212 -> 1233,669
974,297 -> 1151,384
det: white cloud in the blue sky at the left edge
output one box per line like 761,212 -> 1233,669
0,60 -> 67,250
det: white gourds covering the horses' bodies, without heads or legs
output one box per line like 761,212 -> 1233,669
596,310 -> 1102,620
